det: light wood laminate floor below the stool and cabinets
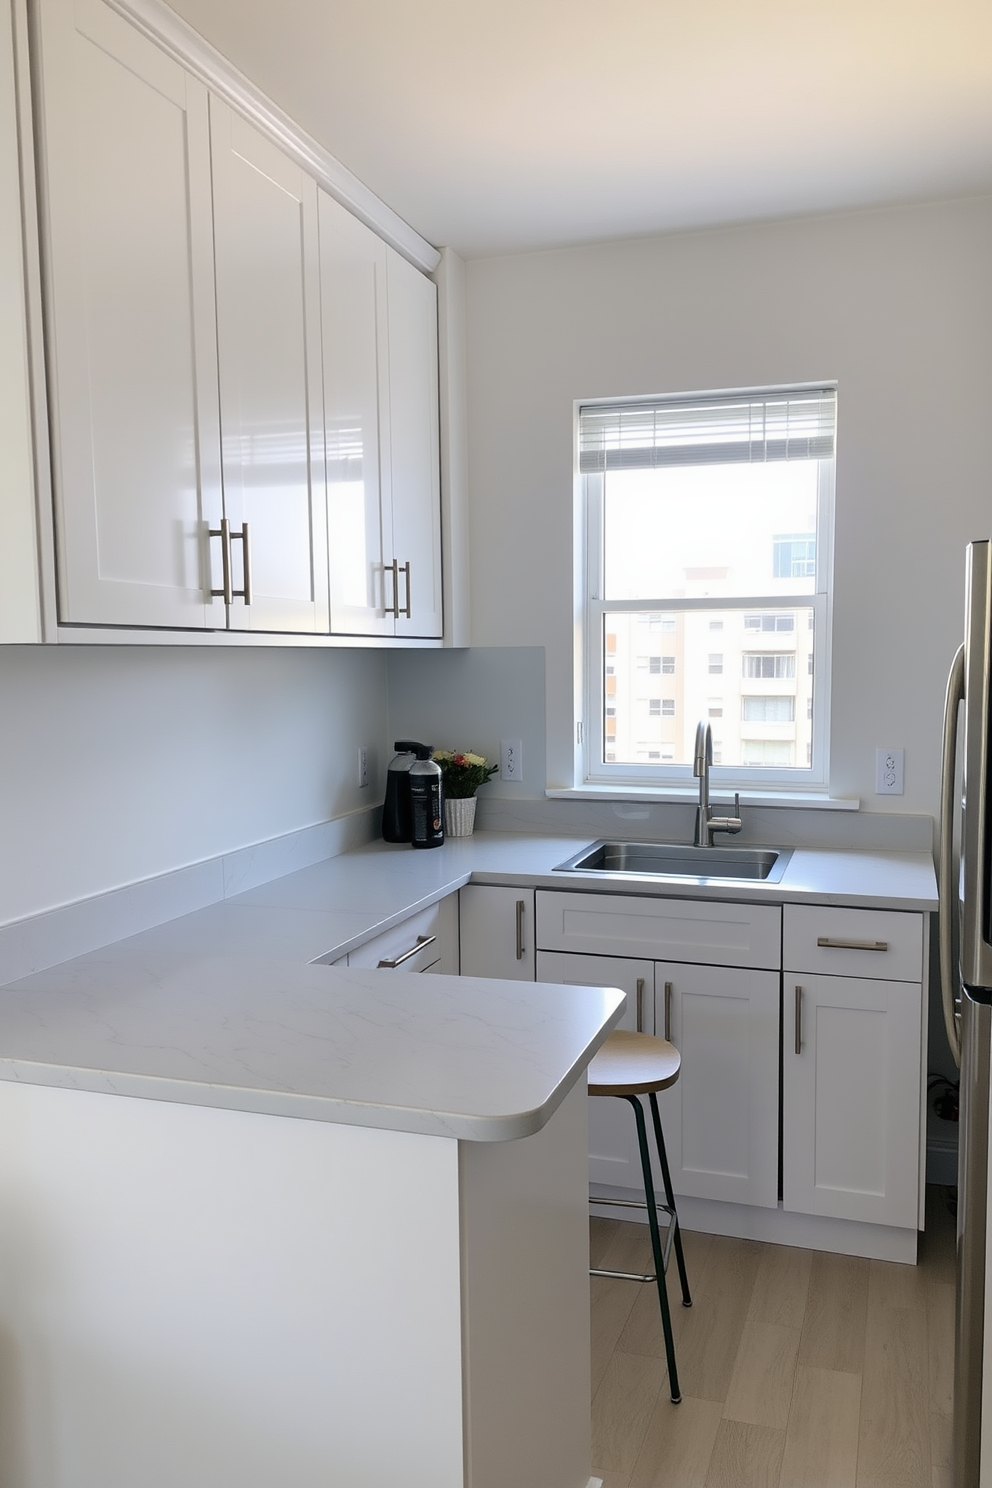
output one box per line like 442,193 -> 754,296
590,1189 -> 955,1488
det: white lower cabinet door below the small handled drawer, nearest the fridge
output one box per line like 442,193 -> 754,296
782,976 -> 921,1228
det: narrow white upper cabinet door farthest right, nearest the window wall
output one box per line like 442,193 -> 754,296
384,248 -> 443,637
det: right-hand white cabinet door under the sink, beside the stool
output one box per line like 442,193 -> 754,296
654,964 -> 779,1208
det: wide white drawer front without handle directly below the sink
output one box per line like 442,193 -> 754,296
537,888 -> 782,972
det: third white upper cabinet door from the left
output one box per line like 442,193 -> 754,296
318,190 -> 394,635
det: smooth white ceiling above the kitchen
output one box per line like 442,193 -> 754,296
171,0 -> 992,257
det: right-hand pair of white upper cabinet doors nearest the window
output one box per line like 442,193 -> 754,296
320,192 -> 442,638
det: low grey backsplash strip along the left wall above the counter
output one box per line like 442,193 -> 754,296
0,806 -> 381,984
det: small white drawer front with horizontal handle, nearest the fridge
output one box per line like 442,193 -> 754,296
782,905 -> 924,982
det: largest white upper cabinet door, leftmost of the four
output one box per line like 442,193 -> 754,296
39,0 -> 225,628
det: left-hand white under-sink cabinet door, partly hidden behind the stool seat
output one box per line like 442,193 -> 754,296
537,951 -> 660,1190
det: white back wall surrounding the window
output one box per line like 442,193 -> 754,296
468,198 -> 992,833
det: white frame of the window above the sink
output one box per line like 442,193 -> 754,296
574,382 -> 836,795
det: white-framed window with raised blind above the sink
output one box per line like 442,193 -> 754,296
579,387 -> 836,789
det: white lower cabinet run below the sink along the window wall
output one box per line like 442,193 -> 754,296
460,885 -> 927,1260
